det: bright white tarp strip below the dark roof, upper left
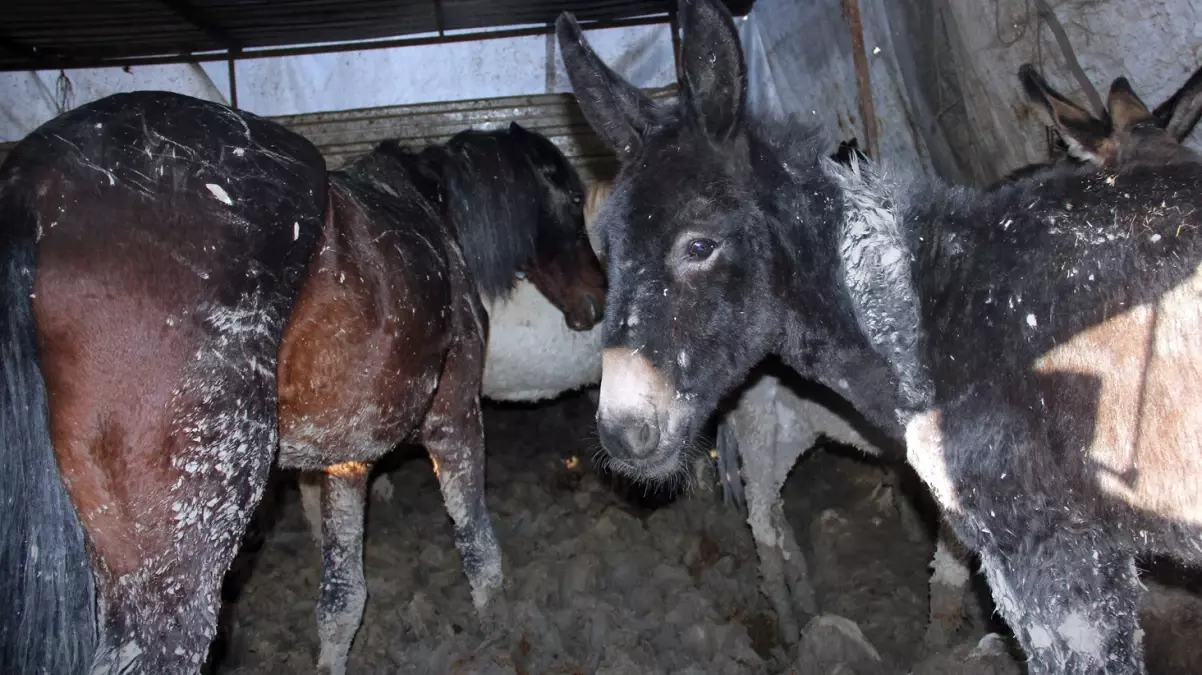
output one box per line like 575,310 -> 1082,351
0,25 -> 676,142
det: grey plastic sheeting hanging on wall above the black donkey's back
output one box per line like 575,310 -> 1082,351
740,0 -> 1202,185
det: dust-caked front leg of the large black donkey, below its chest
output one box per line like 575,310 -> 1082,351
980,536 -> 1144,675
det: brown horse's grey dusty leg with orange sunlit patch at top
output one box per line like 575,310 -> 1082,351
316,461 -> 370,675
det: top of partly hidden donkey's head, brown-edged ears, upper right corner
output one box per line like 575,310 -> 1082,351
1018,64 -> 1202,168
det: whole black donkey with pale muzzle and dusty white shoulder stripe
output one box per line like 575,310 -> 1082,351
558,0 -> 1202,675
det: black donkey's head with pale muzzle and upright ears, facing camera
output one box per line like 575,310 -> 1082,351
557,0 -> 793,479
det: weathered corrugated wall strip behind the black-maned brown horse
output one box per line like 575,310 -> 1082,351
0,86 -> 676,181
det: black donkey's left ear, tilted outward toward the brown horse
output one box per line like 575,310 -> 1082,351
555,12 -> 660,162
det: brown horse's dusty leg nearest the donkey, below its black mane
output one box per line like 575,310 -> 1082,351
422,339 -> 502,613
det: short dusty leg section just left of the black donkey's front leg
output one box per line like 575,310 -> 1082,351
923,524 -> 971,652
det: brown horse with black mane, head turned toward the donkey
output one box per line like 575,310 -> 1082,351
280,125 -> 605,673
